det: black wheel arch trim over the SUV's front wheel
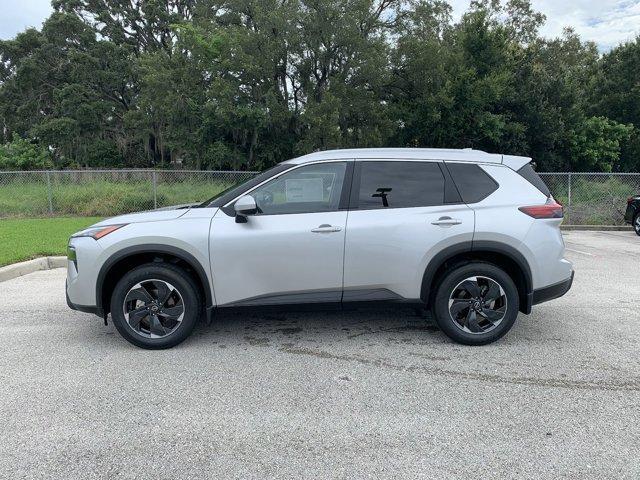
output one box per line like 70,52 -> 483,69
96,244 -> 213,318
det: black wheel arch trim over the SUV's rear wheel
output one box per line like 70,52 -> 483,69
420,241 -> 533,314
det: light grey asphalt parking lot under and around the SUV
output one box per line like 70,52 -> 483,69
0,232 -> 640,479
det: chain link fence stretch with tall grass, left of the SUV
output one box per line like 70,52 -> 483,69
0,170 -> 258,218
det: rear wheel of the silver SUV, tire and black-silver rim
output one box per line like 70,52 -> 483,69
432,262 -> 519,345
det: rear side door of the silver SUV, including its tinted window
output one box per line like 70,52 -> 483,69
343,163 -> 474,301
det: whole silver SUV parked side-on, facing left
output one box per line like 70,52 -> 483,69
66,149 -> 573,348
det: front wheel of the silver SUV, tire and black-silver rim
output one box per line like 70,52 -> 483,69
111,263 -> 203,350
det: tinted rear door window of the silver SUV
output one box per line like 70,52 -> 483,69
357,162 -> 444,209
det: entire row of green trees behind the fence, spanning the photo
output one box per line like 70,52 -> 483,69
0,0 -> 640,171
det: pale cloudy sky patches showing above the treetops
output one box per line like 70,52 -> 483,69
0,0 -> 640,51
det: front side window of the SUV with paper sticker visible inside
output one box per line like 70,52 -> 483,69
250,162 -> 347,215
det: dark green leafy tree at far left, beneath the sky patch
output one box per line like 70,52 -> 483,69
0,13 -> 138,166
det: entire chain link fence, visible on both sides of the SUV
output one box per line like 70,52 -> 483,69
0,170 -> 640,225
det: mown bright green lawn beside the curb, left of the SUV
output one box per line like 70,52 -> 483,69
0,217 -> 100,266
